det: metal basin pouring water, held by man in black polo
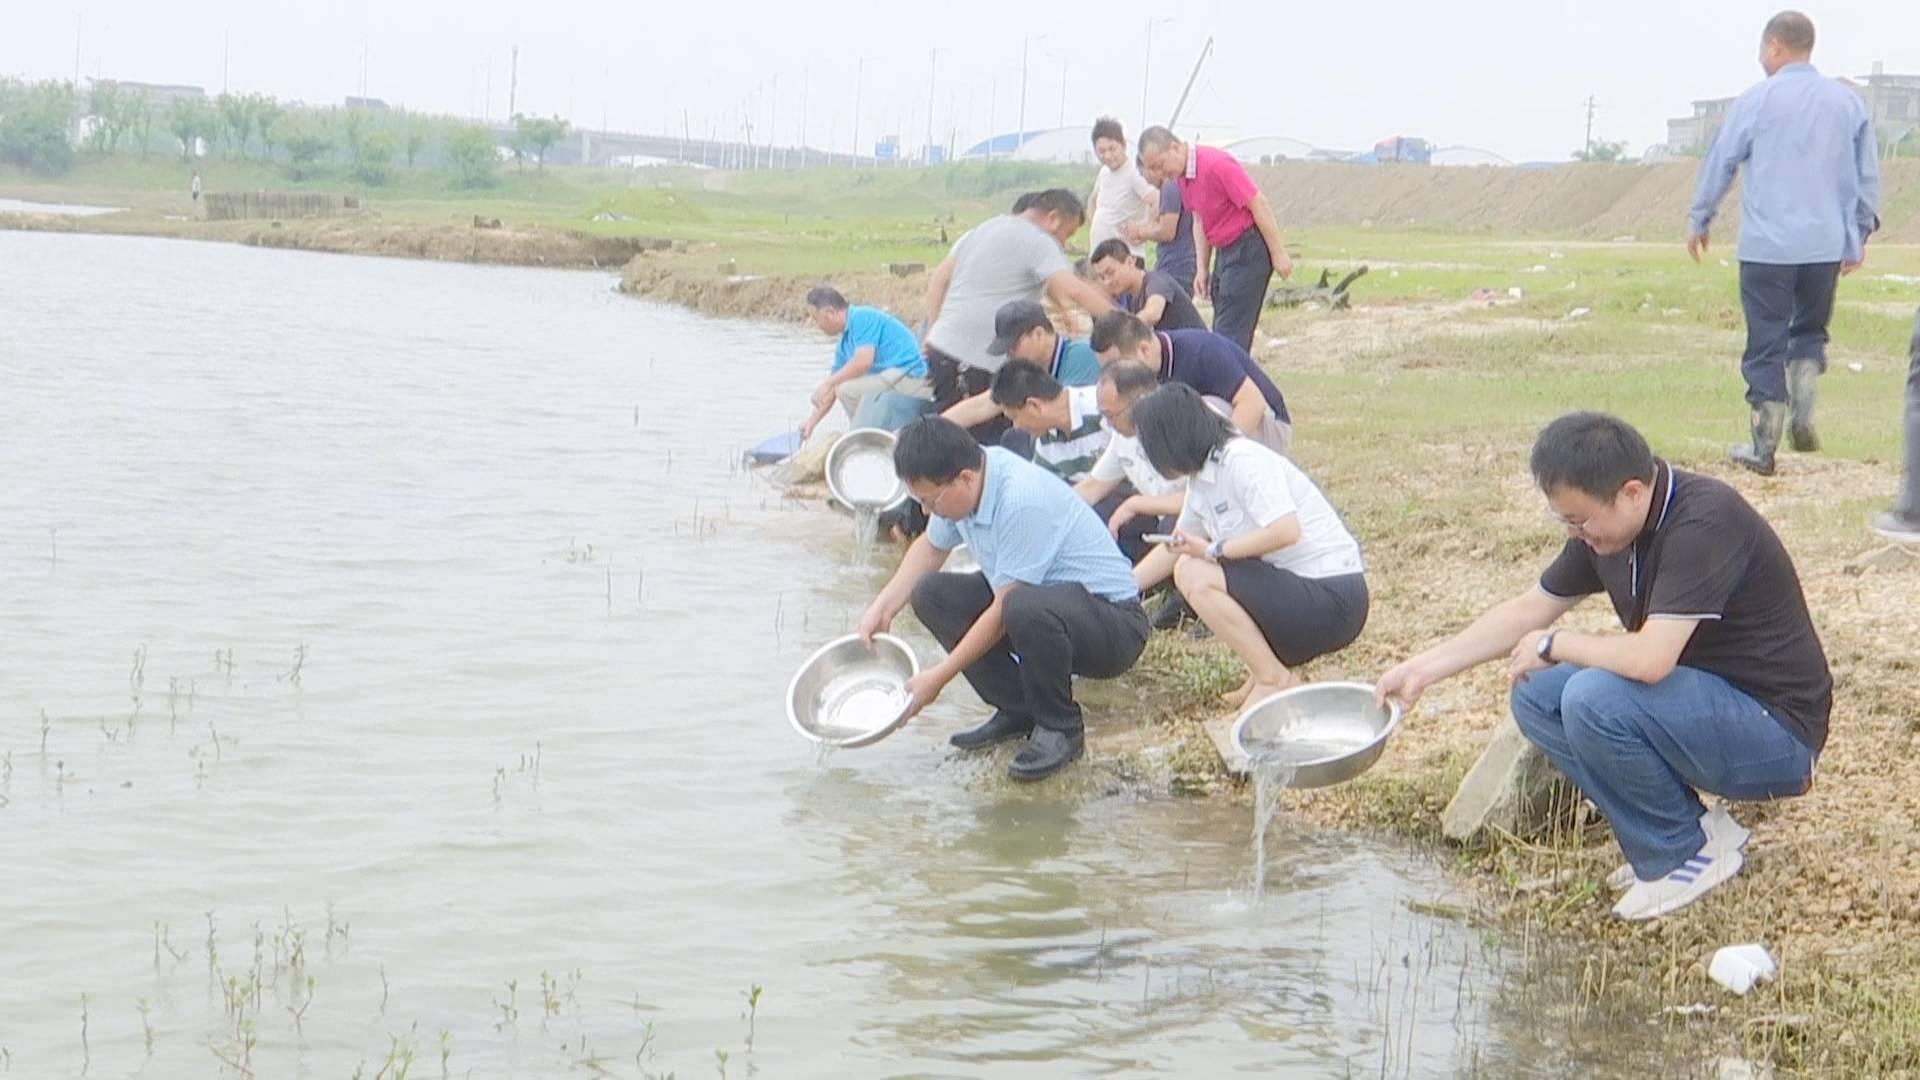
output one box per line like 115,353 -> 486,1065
1233,682 -> 1402,788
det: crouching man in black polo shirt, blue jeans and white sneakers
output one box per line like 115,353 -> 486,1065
1377,413 -> 1834,919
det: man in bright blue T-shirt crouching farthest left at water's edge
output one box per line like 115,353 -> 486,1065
801,284 -> 933,440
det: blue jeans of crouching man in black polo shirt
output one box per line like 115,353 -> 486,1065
1513,663 -> 1814,880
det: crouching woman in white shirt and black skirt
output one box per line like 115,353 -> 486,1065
1133,382 -> 1367,707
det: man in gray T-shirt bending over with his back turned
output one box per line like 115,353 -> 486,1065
924,188 -> 1112,444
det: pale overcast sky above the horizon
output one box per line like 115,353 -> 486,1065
0,0 -> 1920,160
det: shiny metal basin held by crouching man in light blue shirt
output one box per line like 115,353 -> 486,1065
787,634 -> 920,748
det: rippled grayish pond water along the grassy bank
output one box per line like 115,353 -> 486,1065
0,233 -> 1657,1080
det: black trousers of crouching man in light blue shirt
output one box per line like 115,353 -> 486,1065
914,573 -> 1150,734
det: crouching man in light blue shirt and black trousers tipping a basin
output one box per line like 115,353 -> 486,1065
858,417 -> 1148,780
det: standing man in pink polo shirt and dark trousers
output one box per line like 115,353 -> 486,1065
1140,127 -> 1294,352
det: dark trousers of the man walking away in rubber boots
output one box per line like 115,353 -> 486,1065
1740,263 -> 1839,405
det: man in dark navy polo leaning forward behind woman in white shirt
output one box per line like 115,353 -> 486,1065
1092,311 -> 1294,454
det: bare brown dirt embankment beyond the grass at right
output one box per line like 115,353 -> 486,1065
1252,160 -> 1920,242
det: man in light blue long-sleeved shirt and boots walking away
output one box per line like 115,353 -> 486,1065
1686,12 -> 1880,477
